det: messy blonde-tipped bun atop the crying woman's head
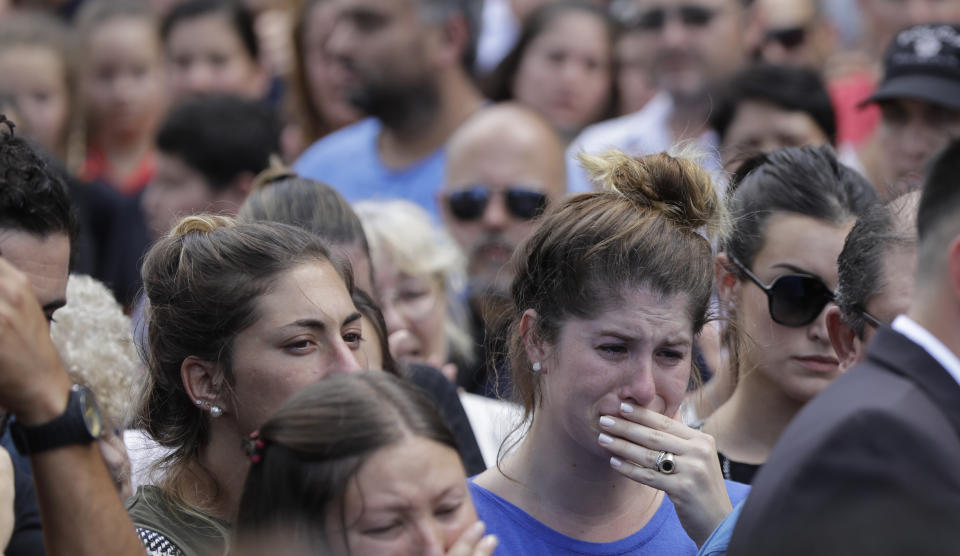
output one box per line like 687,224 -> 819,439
578,149 -> 726,241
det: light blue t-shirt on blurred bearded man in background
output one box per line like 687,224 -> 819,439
293,118 -> 446,221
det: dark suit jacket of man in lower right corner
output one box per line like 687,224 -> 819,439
728,328 -> 960,556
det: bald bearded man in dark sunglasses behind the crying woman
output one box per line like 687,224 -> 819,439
440,103 -> 566,394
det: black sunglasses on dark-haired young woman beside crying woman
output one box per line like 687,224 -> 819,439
730,257 -> 833,328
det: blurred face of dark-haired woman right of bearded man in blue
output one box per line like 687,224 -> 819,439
512,10 -> 613,137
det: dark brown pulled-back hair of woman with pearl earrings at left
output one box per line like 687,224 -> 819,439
139,215 -> 353,506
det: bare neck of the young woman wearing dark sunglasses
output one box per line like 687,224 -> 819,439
703,362 -> 804,464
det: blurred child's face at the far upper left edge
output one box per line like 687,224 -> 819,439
0,45 -> 70,156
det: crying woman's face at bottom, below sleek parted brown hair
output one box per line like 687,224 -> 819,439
327,435 -> 477,556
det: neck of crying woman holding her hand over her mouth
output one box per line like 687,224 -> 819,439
503,418 -> 663,542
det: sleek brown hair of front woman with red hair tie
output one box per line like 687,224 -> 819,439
235,371 -> 457,542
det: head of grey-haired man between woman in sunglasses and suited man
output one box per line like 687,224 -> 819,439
827,191 -> 920,371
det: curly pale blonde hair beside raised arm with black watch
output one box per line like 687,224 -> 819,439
50,274 -> 146,429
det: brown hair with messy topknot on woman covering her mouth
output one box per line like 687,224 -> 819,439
508,151 -> 725,418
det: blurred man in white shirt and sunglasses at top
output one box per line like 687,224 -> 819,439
567,0 -> 759,191
